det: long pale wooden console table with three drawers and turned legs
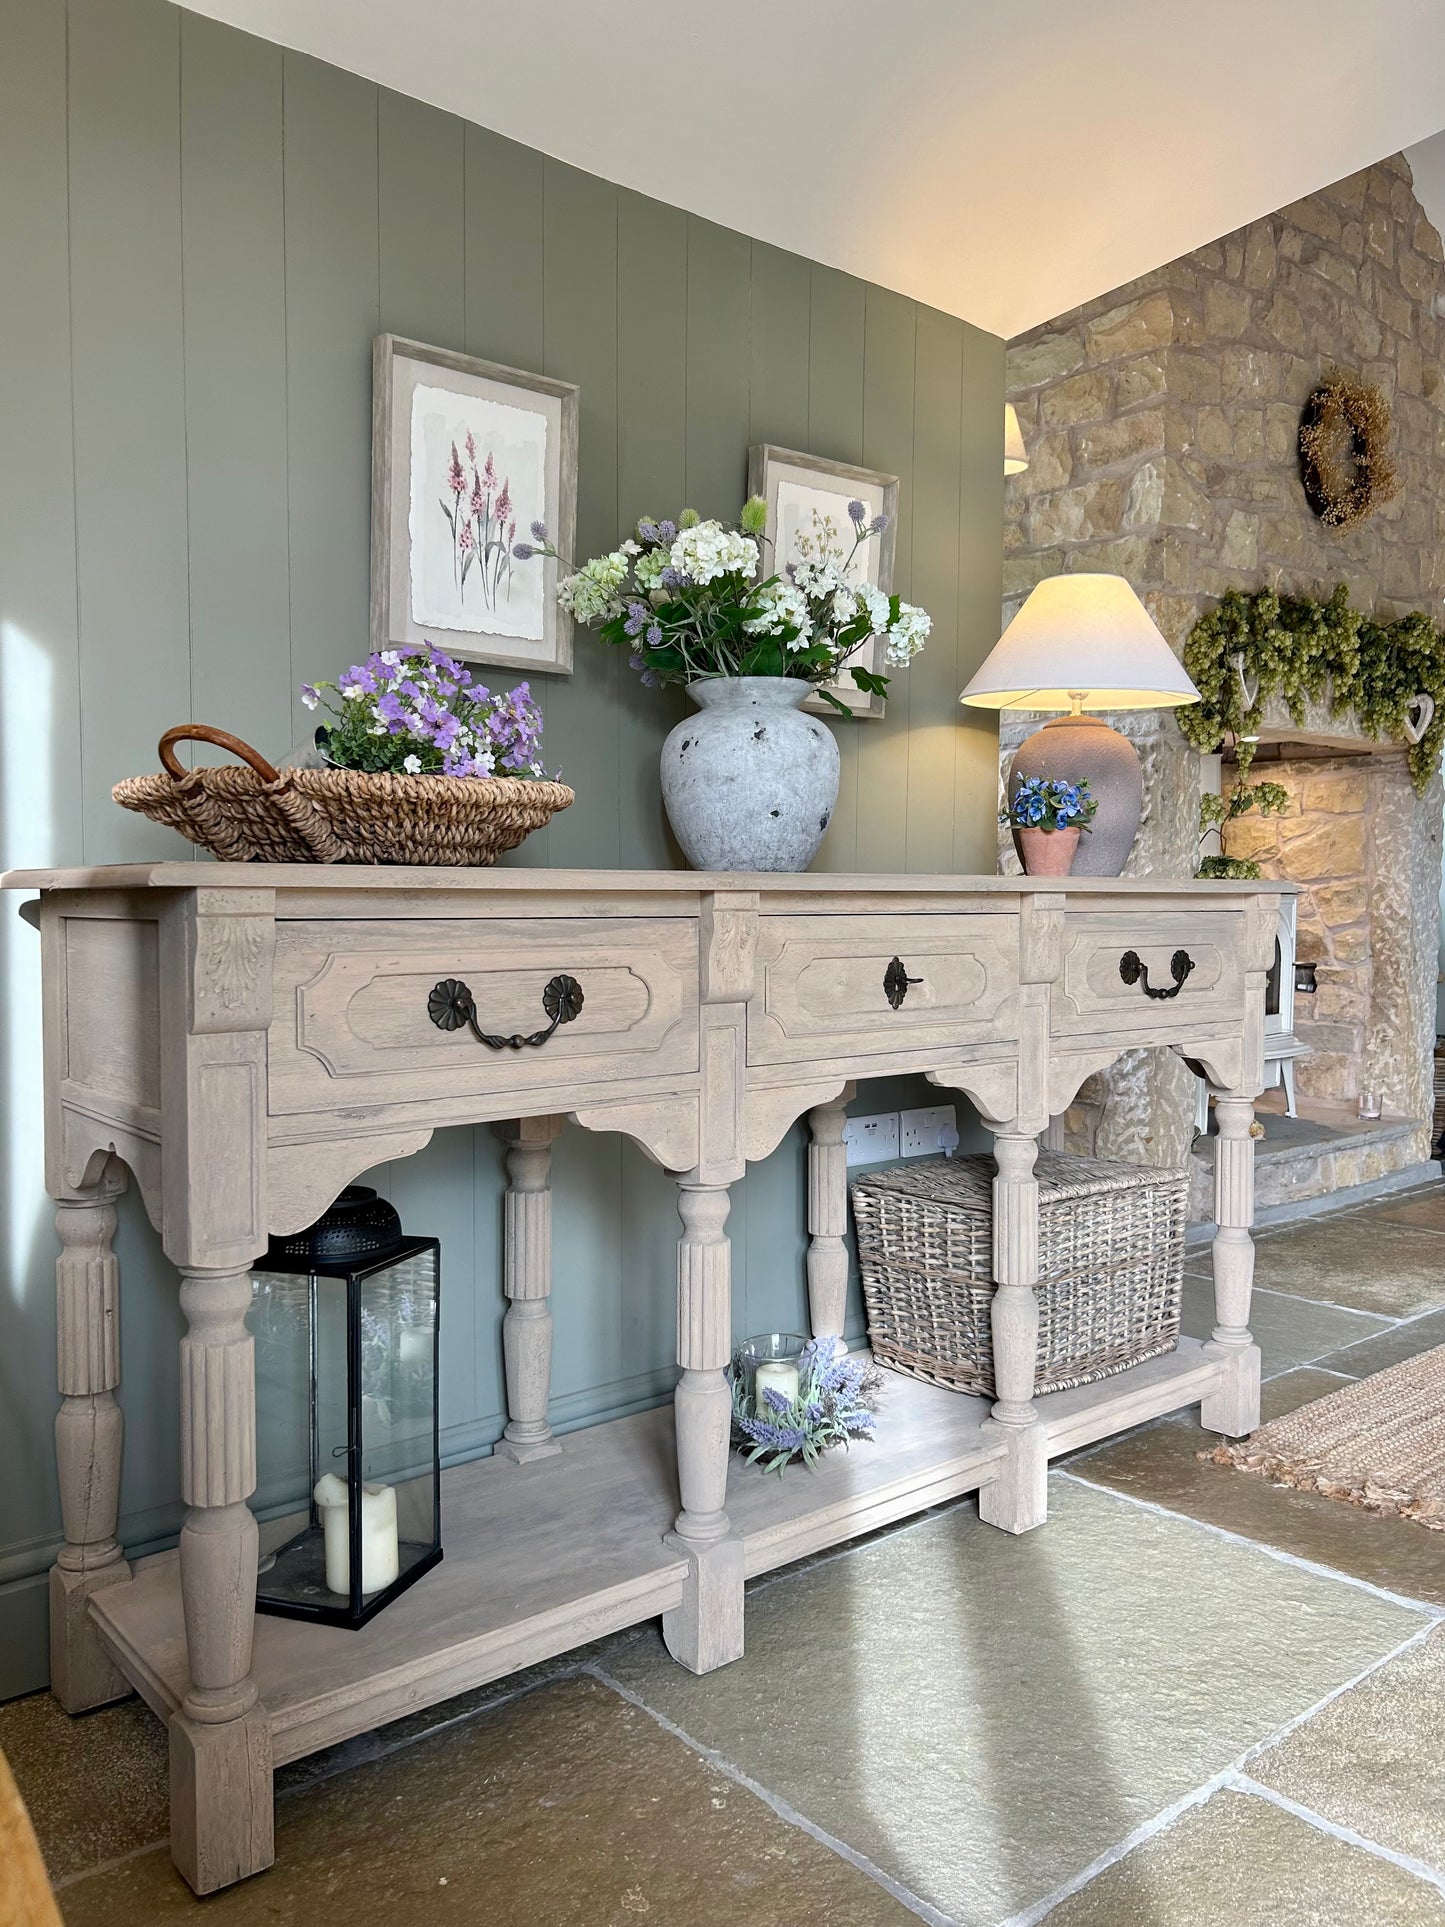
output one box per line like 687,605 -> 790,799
4,863 -> 1279,1892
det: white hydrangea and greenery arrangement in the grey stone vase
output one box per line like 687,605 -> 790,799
512,495 -> 933,715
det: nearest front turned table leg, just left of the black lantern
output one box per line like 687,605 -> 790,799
170,1266 -> 276,1894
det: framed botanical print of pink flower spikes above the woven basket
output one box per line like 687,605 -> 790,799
372,335 -> 578,674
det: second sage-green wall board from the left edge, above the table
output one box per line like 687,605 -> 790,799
67,0 -> 191,861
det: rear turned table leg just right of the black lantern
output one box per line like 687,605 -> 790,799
495,1118 -> 563,1465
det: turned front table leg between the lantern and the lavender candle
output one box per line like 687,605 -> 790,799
663,1175 -> 742,1673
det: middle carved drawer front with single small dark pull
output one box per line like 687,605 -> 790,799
748,913 -> 1019,1064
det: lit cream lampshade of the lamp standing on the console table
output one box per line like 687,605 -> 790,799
959,574 -> 1198,724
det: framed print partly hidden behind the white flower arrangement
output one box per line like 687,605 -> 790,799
748,441 -> 898,717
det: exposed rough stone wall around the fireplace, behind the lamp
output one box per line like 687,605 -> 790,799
1002,156 -> 1445,1164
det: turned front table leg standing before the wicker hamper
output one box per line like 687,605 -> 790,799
979,1131 -> 1048,1532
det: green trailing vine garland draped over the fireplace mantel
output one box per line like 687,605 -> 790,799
1175,582 -> 1445,792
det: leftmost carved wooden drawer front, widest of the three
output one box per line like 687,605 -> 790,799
270,917 -> 697,1116
